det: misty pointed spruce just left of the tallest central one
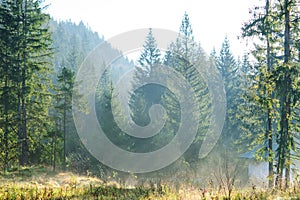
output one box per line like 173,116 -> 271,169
129,28 -> 164,152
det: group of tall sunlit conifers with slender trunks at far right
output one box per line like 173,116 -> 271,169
242,0 -> 300,188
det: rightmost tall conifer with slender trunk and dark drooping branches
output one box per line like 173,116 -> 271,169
275,0 -> 299,187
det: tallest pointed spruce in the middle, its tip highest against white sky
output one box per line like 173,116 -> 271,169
163,13 -> 211,162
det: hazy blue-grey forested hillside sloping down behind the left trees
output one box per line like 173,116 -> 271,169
50,20 -> 133,80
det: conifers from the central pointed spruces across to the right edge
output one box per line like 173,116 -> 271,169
123,0 -> 300,188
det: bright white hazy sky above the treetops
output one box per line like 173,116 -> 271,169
45,0 -> 258,56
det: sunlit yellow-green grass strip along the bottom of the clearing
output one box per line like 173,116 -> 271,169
0,167 -> 300,200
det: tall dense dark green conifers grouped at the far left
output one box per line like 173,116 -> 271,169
0,0 -> 52,169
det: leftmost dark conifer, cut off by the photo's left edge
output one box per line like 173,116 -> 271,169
0,1 -> 17,171
